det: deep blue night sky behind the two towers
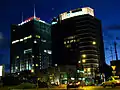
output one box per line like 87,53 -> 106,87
0,0 -> 120,69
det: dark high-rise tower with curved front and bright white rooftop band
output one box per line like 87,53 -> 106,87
51,7 -> 105,76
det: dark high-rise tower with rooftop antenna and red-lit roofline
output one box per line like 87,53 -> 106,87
10,16 -> 52,73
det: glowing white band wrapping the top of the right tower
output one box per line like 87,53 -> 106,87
60,7 -> 94,20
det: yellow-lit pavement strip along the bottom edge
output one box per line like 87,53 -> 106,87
0,86 -> 120,90
